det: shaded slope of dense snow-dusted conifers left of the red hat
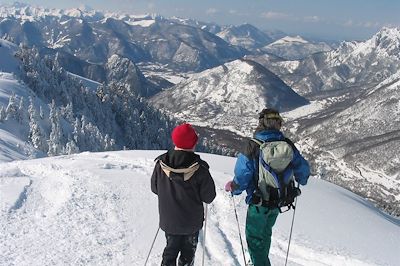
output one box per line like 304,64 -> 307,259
16,47 -> 175,155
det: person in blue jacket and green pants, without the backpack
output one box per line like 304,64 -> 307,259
225,108 -> 310,266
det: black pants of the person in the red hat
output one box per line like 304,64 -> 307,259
161,232 -> 199,266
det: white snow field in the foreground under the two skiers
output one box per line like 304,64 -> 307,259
0,151 -> 400,266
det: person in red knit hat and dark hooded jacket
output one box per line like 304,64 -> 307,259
151,124 -> 216,266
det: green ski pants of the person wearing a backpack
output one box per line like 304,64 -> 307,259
246,205 -> 279,266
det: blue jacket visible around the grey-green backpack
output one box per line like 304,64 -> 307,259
232,130 -> 310,204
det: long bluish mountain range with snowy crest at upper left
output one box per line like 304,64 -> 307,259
0,2 -> 244,71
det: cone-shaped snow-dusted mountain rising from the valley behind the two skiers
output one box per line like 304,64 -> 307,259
151,60 -> 307,134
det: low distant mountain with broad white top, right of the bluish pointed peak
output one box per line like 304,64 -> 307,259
261,36 -> 332,60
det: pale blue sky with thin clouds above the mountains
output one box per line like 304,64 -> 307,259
2,0 -> 400,40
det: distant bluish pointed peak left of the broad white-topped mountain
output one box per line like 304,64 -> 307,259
216,24 -> 273,51
